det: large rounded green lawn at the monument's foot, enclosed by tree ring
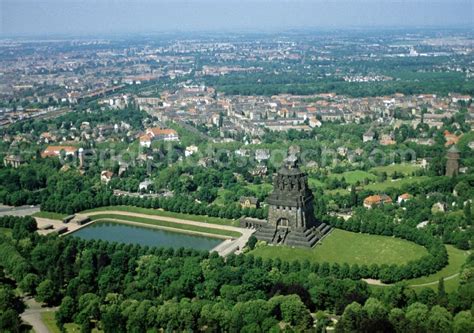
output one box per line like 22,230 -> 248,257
250,229 -> 427,265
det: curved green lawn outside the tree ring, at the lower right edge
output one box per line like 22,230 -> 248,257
406,245 -> 469,292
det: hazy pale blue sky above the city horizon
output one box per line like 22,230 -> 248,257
0,0 -> 474,36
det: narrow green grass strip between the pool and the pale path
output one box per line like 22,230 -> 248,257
90,214 -> 242,238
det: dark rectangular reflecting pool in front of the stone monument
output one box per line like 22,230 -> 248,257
71,221 -> 222,250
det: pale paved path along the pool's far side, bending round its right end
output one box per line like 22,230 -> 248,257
85,210 -> 255,257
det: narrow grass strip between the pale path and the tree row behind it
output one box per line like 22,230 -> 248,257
81,206 -> 238,226
